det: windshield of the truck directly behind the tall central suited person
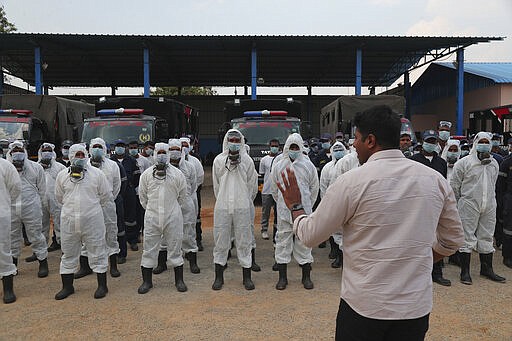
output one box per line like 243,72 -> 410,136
233,121 -> 300,145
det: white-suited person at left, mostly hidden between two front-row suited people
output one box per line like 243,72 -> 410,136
37,142 -> 66,251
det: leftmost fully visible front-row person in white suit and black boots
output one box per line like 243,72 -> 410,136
55,144 -> 113,300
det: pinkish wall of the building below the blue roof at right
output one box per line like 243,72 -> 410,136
411,84 -> 512,133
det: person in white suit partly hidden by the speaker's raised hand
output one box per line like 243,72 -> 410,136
272,133 -> 319,290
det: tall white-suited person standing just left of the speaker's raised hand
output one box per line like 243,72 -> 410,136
212,129 -> 258,290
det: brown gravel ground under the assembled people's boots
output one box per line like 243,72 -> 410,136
0,166 -> 512,340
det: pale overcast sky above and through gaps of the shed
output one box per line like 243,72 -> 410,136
0,0 -> 512,94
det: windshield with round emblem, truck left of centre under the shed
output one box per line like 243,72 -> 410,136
82,120 -> 153,144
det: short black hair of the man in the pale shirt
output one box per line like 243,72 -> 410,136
354,105 -> 402,149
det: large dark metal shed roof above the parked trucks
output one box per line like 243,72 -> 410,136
0,33 -> 503,87
